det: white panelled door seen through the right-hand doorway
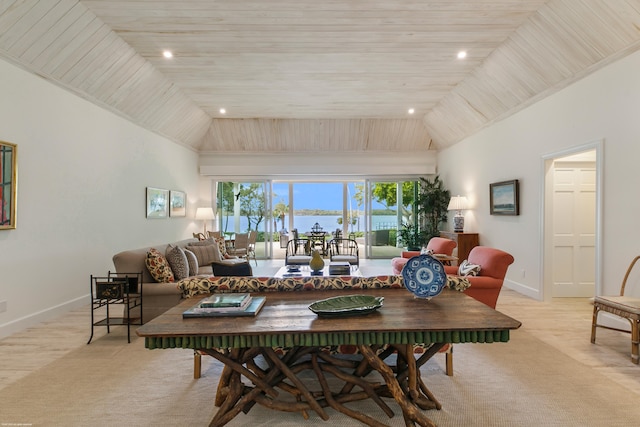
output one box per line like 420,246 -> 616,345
552,159 -> 596,297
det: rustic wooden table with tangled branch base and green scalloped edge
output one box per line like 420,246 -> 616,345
137,289 -> 520,426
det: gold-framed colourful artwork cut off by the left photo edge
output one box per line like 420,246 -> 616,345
0,141 -> 18,230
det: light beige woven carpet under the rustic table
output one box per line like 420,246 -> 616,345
0,328 -> 640,427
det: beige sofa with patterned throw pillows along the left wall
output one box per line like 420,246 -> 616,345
113,239 -> 252,323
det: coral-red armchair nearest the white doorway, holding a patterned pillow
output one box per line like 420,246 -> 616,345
444,246 -> 514,308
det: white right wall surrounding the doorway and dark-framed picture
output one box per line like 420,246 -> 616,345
438,46 -> 640,298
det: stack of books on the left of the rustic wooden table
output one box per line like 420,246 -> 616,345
182,293 -> 266,317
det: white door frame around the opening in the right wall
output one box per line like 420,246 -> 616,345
540,139 -> 604,301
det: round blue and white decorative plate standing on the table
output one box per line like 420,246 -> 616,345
402,254 -> 447,299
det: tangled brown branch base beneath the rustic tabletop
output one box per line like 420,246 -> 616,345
201,344 -> 440,427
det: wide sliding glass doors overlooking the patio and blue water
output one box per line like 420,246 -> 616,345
216,180 -> 417,259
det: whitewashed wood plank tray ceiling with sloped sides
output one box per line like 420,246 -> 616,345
0,0 -> 640,153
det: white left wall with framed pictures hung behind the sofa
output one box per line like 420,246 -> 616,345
0,60 -> 209,337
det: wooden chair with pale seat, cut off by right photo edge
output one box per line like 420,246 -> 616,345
591,256 -> 640,365
